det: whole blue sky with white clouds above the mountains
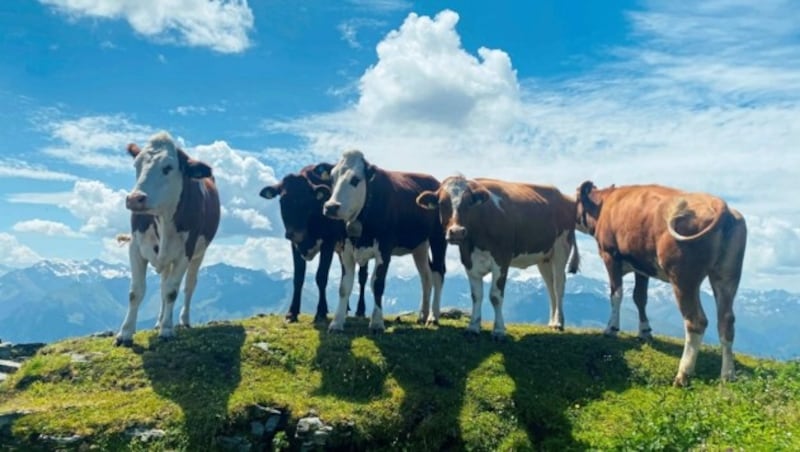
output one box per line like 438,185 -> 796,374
0,0 -> 800,291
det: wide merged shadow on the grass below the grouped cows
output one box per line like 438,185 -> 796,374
315,319 -> 642,450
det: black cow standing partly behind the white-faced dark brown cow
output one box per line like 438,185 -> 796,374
259,163 -> 367,323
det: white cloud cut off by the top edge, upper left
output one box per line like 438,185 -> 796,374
40,0 -> 254,53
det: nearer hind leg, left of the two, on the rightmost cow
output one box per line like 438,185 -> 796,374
672,281 -> 708,386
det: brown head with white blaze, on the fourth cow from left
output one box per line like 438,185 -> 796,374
417,176 -> 491,245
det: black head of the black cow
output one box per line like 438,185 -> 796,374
259,163 -> 333,258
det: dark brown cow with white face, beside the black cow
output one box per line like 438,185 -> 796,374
318,150 -> 447,332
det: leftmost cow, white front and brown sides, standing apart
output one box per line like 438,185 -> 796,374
116,132 -> 220,345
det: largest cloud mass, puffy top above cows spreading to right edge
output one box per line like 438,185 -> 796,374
267,4 -> 800,289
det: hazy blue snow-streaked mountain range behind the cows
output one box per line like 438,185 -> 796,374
0,260 -> 800,359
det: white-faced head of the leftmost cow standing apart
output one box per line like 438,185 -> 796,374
125,132 -> 211,215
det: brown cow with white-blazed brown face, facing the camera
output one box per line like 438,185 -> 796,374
417,176 -> 579,339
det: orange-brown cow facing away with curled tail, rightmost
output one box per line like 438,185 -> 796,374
576,181 -> 747,386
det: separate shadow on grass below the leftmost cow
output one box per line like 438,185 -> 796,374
141,324 -> 245,450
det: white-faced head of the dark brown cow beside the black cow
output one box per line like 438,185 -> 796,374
322,151 -> 375,223
